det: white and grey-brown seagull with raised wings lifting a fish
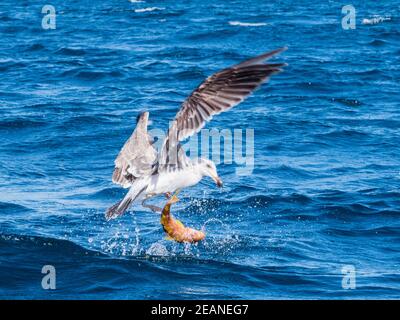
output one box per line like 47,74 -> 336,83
105,47 -> 287,220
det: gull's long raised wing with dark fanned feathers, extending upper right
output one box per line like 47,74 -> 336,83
159,48 -> 286,169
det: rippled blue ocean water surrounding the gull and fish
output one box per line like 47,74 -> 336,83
0,0 -> 400,299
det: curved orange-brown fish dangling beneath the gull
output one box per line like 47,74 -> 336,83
161,195 -> 206,243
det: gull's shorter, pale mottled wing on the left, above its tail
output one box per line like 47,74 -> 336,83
112,112 -> 157,188
